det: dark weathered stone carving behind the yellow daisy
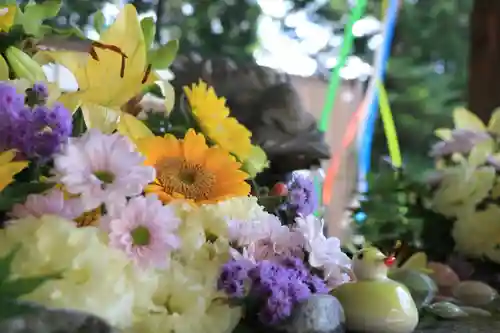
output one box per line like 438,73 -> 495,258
171,56 -> 330,183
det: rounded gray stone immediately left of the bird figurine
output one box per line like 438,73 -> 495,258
286,295 -> 345,333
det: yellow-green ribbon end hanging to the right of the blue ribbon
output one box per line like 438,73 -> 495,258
377,81 -> 403,168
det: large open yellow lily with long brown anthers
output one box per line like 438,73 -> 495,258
41,5 -> 159,136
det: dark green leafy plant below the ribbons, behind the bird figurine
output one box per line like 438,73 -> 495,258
353,161 -> 455,261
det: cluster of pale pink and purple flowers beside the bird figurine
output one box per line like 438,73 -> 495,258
218,213 -> 351,329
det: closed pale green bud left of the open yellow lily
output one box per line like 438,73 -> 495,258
5,46 -> 46,83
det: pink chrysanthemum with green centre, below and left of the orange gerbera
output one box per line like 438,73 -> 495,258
101,195 -> 181,268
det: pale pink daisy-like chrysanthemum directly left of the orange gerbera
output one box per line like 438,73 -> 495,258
54,129 -> 155,210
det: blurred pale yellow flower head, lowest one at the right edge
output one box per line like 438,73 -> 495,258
452,205 -> 500,263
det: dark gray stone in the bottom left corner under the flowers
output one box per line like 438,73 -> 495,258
0,306 -> 119,333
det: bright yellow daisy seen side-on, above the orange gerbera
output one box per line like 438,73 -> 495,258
184,80 -> 252,161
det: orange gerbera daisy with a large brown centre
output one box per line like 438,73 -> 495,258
137,129 -> 250,204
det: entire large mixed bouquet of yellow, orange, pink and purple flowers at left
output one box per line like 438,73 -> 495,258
0,1 -> 350,333
